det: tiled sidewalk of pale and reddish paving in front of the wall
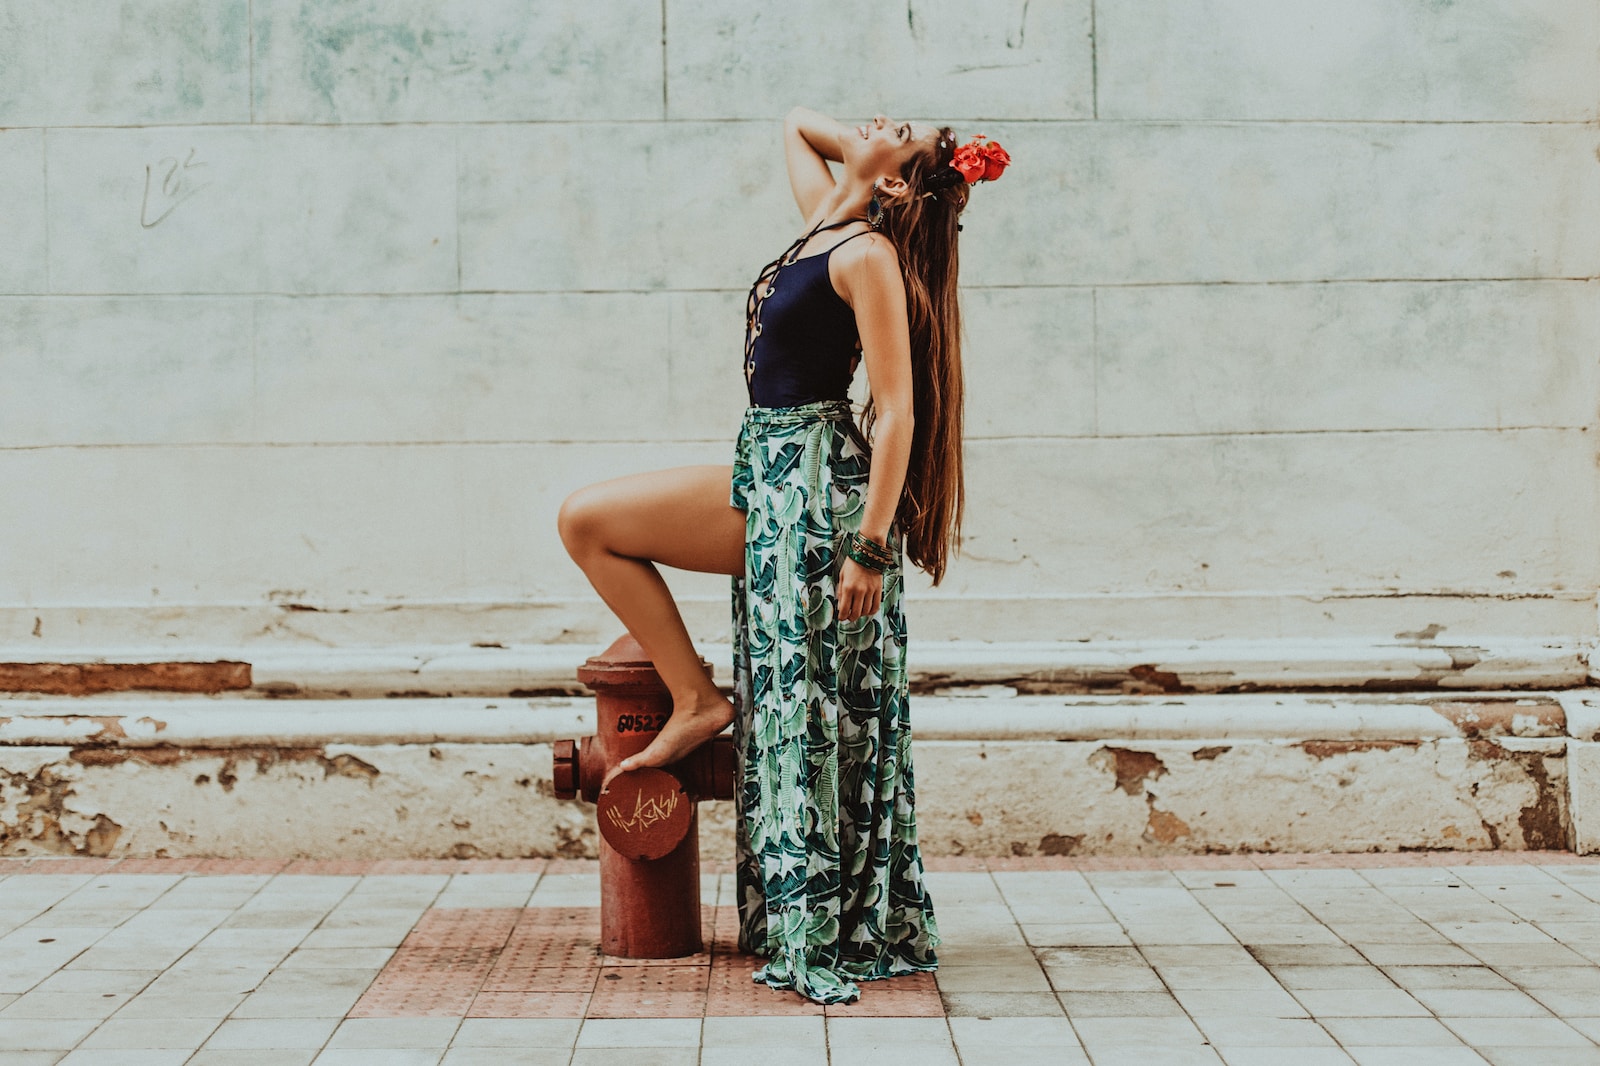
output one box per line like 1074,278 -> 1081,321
0,853 -> 1600,1066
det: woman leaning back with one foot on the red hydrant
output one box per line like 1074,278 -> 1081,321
560,107 -> 1010,1002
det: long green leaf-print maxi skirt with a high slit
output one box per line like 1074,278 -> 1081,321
731,400 -> 939,1004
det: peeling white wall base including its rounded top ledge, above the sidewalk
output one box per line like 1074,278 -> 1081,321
0,685 -> 1600,858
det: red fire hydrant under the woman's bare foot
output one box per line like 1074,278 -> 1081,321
555,634 -> 734,959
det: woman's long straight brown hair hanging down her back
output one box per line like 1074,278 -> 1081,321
862,126 -> 966,584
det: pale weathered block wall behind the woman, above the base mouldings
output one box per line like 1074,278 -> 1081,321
0,0 -> 1600,655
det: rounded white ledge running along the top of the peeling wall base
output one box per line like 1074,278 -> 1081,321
0,687 -> 1580,747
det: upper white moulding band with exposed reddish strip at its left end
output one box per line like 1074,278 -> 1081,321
0,634 -> 1590,698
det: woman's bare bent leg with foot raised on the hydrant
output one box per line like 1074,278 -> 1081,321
558,466 -> 744,783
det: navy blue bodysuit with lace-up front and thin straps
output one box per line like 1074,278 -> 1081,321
744,219 -> 870,407
